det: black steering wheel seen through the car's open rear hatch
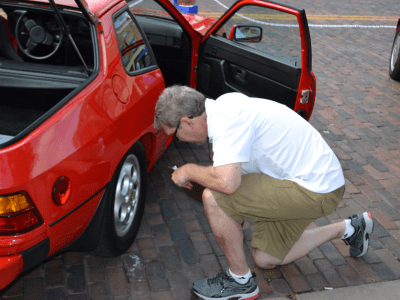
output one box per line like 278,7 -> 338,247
15,12 -> 63,60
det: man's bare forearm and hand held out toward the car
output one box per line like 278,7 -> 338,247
172,163 -> 242,195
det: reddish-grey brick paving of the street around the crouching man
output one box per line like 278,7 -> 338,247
0,0 -> 400,300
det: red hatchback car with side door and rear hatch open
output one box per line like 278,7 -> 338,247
0,0 -> 316,289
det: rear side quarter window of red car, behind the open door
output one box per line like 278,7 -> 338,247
114,11 -> 154,73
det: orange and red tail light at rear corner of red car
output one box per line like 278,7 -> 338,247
0,192 -> 43,235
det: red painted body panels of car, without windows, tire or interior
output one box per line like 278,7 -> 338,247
0,0 -> 316,290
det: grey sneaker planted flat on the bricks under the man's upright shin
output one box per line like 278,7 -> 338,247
193,269 -> 260,300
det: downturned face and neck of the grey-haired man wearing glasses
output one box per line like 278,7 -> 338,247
161,114 -> 208,144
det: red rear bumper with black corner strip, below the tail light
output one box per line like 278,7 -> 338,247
0,238 -> 50,290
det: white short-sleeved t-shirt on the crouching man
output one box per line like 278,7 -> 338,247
205,93 -> 345,193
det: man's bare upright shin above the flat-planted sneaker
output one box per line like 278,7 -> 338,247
203,189 -> 249,275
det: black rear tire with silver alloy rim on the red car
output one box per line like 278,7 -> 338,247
93,143 -> 146,257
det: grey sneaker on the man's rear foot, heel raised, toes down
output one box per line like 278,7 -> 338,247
343,212 -> 374,257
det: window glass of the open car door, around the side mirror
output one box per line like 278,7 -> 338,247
217,5 -> 301,67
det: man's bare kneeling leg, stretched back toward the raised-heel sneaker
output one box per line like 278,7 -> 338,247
253,221 -> 346,269
